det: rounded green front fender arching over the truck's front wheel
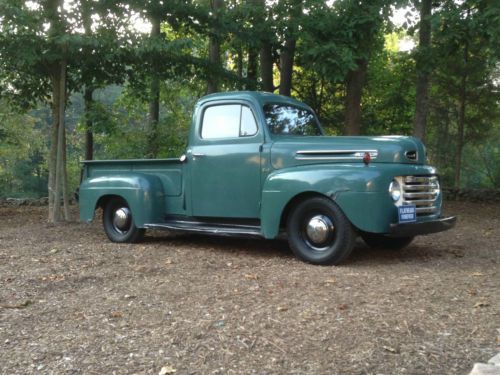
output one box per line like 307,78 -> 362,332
261,163 -> 435,238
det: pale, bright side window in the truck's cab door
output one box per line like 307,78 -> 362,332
201,104 -> 258,139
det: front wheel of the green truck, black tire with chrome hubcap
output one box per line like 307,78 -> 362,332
287,197 -> 356,265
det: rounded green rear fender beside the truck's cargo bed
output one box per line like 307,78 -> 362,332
80,173 -> 165,228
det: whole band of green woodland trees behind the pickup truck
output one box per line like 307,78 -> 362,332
0,0 -> 500,221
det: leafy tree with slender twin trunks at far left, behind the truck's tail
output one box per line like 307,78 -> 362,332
0,0 -> 136,222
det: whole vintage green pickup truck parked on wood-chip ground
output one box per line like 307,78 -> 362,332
80,92 -> 456,264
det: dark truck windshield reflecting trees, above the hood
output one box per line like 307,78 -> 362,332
264,104 -> 322,136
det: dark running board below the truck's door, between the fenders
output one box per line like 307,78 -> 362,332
144,220 -> 263,237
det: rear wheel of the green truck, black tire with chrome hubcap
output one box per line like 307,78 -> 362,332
102,198 -> 146,243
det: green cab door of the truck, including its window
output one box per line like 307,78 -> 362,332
188,103 -> 263,218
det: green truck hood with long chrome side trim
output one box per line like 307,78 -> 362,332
271,136 -> 426,169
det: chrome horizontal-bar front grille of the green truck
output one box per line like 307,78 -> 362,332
403,176 -> 439,216
